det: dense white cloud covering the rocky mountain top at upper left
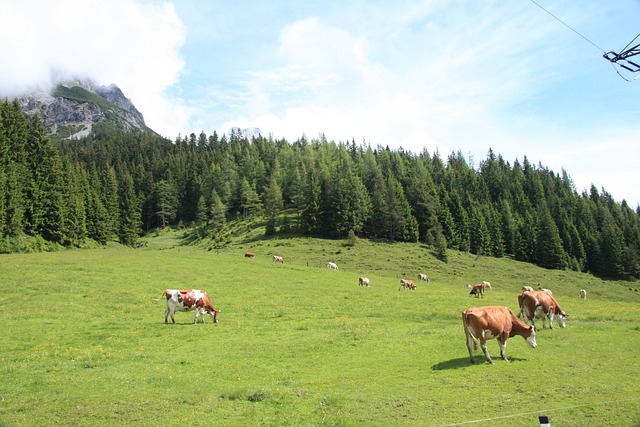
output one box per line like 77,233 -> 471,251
0,0 -> 189,137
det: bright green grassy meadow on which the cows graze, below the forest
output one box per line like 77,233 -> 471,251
0,234 -> 640,426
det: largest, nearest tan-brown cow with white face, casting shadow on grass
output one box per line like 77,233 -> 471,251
462,306 -> 538,364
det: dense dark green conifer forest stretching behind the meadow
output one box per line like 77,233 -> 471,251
0,100 -> 640,278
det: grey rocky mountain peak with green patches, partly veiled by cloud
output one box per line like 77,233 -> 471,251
18,81 -> 153,139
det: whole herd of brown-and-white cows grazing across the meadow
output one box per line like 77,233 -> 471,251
162,252 -> 587,364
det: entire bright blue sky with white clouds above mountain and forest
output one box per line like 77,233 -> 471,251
0,0 -> 640,208
